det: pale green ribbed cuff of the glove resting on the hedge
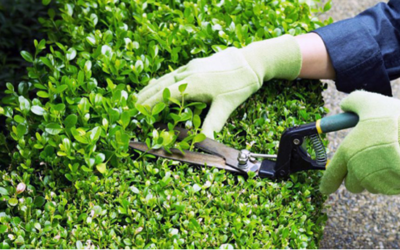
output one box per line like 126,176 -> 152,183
240,35 -> 302,82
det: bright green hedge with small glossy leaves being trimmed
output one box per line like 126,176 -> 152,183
0,0 -> 330,248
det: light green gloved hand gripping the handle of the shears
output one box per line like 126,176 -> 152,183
320,91 -> 400,195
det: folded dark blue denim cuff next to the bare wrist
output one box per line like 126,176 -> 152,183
313,18 -> 392,96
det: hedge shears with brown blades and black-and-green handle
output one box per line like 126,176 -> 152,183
130,112 -> 359,179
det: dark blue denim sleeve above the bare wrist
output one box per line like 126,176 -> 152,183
314,0 -> 400,96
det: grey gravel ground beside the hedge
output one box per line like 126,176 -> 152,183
320,0 -> 400,248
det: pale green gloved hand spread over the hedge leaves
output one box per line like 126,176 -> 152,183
137,35 -> 301,138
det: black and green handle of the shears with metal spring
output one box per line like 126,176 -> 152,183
259,112 -> 359,178
